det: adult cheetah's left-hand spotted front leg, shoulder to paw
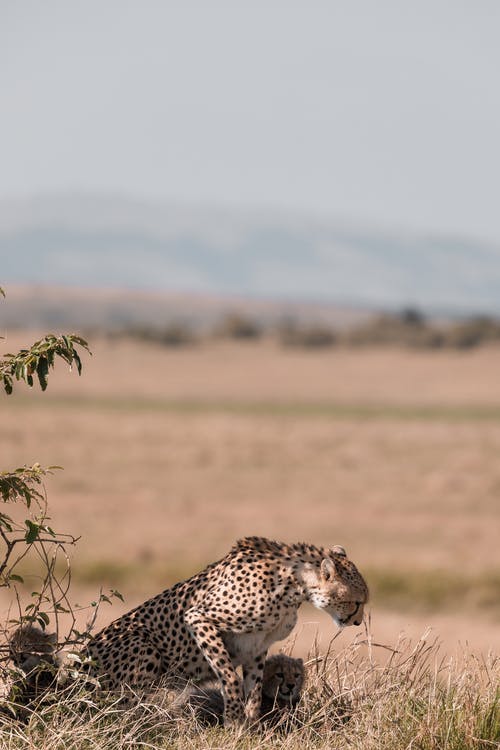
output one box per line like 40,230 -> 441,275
184,609 -> 244,726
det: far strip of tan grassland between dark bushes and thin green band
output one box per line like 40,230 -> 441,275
2,331 -> 500,408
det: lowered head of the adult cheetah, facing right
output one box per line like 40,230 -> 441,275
307,546 -> 368,627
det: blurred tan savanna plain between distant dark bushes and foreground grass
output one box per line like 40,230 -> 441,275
0,332 -> 500,747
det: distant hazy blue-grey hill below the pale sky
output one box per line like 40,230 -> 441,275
0,195 -> 500,313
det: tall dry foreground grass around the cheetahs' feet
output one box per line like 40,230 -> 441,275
0,636 -> 500,750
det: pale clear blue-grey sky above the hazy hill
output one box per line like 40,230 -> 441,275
0,0 -> 500,242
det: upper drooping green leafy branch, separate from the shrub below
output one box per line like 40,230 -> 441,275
0,333 -> 91,395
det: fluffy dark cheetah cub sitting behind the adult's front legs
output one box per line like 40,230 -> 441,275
178,654 -> 304,726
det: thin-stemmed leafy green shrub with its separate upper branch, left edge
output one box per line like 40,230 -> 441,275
0,287 -> 121,656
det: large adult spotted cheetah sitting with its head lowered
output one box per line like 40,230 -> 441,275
87,537 -> 368,725
